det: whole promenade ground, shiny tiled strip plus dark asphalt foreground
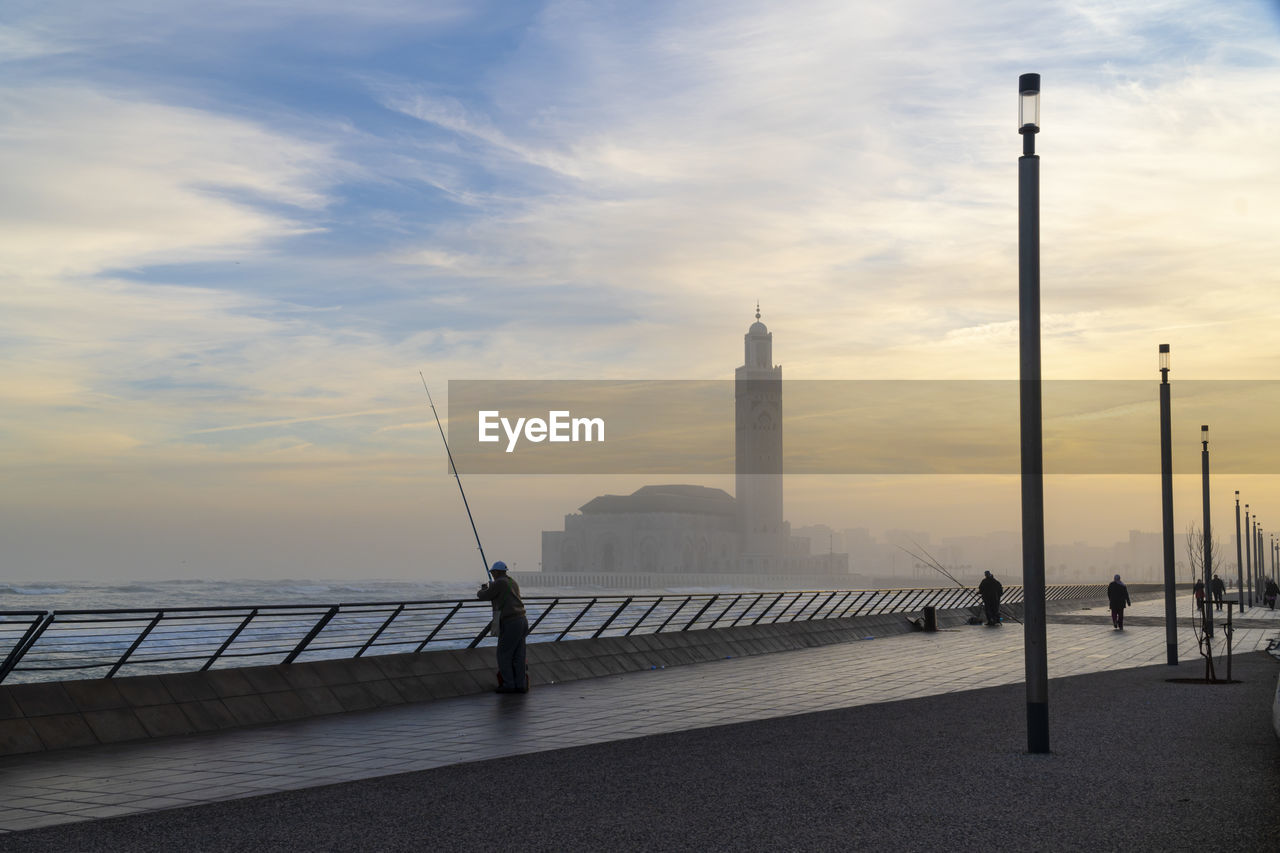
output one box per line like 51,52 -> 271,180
0,598 -> 1280,850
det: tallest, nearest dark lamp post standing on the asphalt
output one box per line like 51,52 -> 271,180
1018,74 -> 1048,753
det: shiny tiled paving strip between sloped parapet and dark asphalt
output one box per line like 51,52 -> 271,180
0,598 -> 1280,831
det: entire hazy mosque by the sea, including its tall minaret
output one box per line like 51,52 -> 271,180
515,306 -> 850,589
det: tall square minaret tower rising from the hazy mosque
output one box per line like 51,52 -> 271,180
733,302 -> 787,574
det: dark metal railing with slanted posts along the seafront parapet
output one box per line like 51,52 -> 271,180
0,584 -> 1106,681
